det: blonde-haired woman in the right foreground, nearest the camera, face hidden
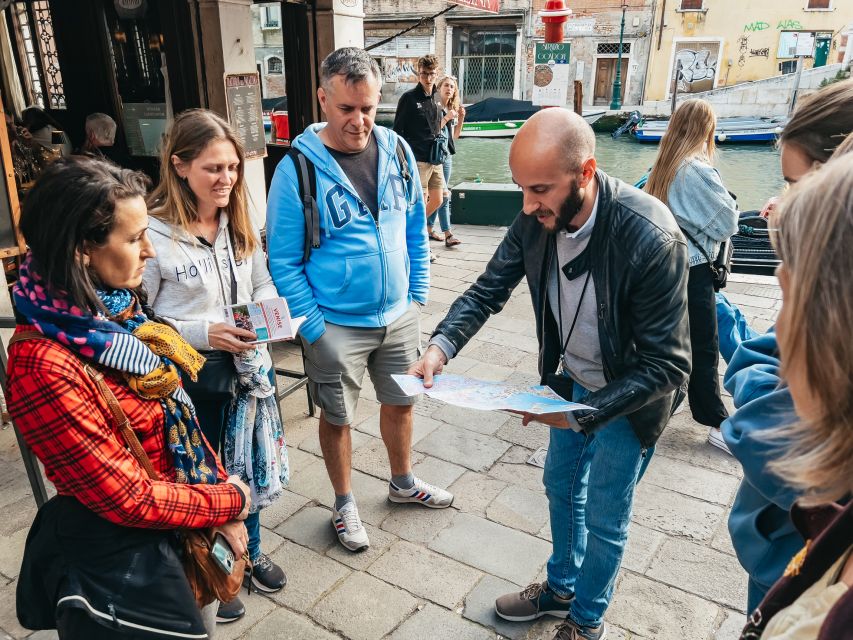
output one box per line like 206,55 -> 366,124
741,151 -> 853,640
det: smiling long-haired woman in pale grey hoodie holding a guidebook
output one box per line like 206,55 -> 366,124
143,109 -> 286,622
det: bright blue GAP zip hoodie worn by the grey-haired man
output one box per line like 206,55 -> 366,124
267,124 -> 429,343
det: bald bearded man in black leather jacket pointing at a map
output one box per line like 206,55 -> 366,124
410,109 -> 690,640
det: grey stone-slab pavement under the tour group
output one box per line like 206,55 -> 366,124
0,226 -> 781,640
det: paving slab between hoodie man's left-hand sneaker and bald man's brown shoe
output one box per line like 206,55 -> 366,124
368,541 -> 483,609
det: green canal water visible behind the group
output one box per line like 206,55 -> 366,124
450,133 -> 784,211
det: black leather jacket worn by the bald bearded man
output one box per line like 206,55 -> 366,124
435,171 -> 690,448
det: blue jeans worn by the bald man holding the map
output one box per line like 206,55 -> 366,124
543,383 -> 654,627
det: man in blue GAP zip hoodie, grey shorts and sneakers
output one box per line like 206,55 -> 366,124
267,47 -> 453,551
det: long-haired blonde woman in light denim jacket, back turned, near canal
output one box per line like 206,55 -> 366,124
646,100 -> 738,451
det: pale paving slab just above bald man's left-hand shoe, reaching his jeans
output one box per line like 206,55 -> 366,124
429,513 -> 551,584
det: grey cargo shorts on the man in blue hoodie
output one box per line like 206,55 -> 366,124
303,302 -> 420,426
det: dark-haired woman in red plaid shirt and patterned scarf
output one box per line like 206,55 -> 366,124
8,157 -> 250,639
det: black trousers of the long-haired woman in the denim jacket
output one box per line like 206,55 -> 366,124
687,263 -> 729,428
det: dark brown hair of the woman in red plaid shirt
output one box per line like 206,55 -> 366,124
21,156 -> 151,313
